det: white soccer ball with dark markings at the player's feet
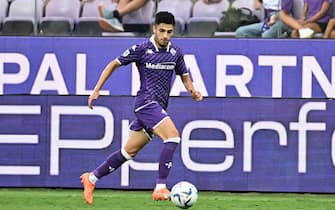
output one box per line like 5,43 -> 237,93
171,181 -> 198,209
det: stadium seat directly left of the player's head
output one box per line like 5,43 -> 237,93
122,0 -> 155,34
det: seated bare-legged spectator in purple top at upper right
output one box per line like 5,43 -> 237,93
279,0 -> 332,38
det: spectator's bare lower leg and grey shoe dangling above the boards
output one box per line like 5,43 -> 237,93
98,0 -> 148,32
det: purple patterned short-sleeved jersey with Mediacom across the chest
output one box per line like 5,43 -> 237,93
117,36 -> 188,109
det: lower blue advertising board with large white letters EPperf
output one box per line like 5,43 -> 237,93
0,95 -> 335,193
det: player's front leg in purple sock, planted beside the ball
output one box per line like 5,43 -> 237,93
152,117 -> 180,200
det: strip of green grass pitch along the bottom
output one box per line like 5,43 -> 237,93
0,188 -> 335,210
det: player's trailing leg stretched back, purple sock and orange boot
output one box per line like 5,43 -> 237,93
80,131 -> 149,204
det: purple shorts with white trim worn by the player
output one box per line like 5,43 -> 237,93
129,101 -> 169,138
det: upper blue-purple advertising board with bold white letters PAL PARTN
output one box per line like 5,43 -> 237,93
0,37 -> 335,98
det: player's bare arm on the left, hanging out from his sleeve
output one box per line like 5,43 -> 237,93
88,60 -> 121,109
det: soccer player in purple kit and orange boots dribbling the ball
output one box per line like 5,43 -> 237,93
81,12 -> 202,204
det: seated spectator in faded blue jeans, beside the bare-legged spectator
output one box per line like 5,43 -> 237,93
235,0 -> 283,38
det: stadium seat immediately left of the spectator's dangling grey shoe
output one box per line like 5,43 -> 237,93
75,0 -> 110,36
